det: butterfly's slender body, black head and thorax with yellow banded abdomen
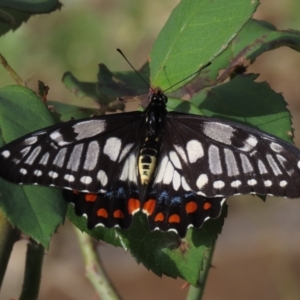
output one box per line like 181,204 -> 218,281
138,91 -> 168,186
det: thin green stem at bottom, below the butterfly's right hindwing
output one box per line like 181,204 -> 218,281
186,241 -> 216,300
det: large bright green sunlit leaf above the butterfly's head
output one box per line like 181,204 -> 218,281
150,0 -> 258,89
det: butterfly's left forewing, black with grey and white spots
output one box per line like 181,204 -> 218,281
0,112 -> 145,193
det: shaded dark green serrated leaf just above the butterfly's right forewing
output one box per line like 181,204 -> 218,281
190,74 -> 292,142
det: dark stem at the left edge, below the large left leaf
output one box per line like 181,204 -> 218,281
0,209 -> 20,288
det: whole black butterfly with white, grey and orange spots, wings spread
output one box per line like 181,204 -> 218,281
0,90 -> 300,237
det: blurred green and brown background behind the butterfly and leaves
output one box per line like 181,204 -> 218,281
0,0 -> 300,300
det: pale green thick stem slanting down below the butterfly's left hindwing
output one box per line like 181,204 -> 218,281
75,228 -> 121,300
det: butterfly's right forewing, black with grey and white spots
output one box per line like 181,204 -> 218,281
164,113 -> 300,198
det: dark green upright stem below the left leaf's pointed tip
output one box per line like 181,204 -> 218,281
19,240 -> 45,300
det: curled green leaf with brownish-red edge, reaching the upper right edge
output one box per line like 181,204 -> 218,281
183,19 -> 300,94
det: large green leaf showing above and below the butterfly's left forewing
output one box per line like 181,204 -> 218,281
0,86 -> 66,247
